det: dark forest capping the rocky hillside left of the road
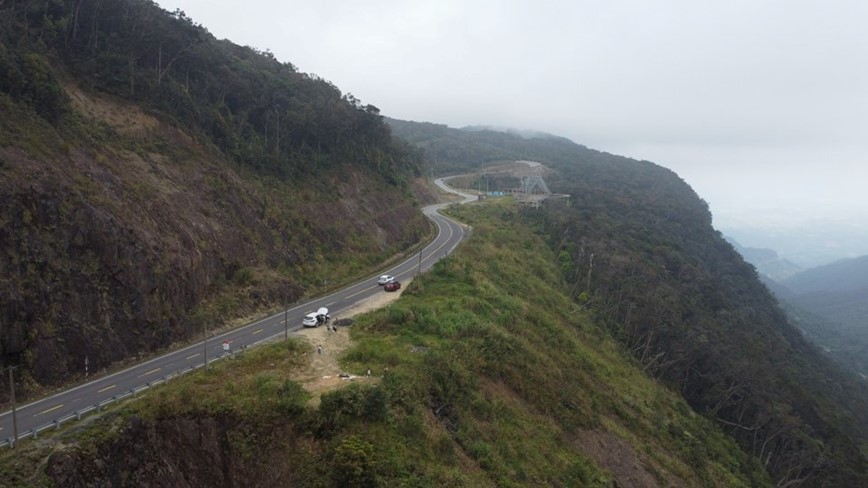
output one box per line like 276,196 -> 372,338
0,0 -> 418,178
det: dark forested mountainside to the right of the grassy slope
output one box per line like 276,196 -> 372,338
393,123 -> 868,486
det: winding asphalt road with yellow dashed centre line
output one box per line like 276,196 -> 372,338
0,178 -> 477,445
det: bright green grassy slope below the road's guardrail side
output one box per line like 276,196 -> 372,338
6,202 -> 769,486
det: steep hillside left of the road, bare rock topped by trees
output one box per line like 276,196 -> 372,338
0,0 -> 430,401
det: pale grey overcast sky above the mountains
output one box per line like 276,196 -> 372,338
158,0 -> 868,260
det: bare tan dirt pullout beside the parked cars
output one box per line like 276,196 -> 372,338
284,280 -> 410,403
